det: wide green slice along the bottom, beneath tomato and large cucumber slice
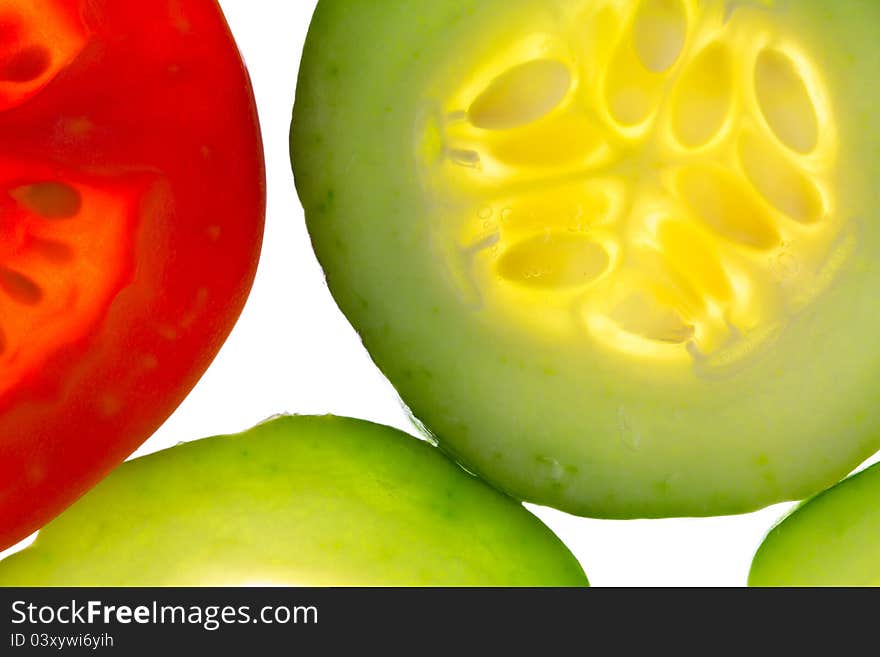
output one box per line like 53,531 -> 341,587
0,416 -> 587,586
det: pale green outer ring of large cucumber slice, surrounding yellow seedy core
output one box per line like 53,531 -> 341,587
291,0 -> 880,518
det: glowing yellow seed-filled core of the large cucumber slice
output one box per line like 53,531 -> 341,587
417,0 -> 852,365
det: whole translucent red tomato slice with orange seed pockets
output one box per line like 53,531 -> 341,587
0,0 -> 265,548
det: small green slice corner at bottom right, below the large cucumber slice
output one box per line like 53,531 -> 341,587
749,464 -> 880,586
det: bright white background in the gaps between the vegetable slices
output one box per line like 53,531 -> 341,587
3,0 -> 876,586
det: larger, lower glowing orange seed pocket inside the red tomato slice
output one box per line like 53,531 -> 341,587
0,163 -> 135,394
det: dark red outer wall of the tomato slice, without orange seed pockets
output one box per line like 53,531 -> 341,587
0,0 -> 266,548
